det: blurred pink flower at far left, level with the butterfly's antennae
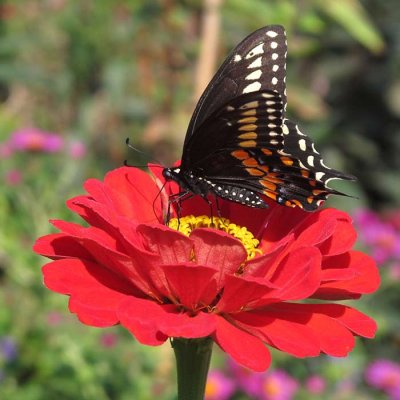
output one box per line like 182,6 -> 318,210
9,128 -> 64,153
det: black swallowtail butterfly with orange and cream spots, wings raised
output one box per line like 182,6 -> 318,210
163,25 -> 355,211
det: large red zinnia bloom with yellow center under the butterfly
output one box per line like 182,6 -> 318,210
34,167 -> 379,371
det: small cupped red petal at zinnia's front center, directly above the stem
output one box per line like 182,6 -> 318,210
163,264 -> 217,310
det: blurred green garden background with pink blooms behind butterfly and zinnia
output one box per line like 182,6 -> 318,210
0,0 -> 400,400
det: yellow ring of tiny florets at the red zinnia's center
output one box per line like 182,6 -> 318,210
168,215 -> 262,260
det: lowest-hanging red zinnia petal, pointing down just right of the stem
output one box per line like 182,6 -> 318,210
214,317 -> 271,372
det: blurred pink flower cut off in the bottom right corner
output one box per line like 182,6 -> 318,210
365,359 -> 400,400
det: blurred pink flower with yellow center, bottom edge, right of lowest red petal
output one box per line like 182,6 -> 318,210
259,369 -> 299,400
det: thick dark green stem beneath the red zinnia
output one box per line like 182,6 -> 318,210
172,337 -> 213,400
